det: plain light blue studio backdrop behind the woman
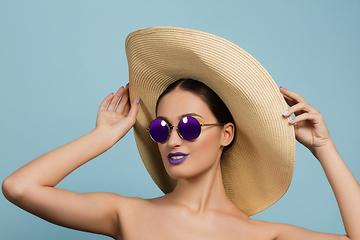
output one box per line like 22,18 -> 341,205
0,0 -> 360,240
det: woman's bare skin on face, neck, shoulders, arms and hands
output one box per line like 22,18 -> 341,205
2,86 -> 360,240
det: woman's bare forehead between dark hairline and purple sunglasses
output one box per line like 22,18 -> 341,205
156,89 -> 213,119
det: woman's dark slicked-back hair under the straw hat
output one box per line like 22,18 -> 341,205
156,78 -> 235,153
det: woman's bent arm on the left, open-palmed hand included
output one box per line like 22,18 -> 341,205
2,84 -> 138,238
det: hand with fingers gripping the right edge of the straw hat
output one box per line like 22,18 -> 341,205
280,87 -> 332,156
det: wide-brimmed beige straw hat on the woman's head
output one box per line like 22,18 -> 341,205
125,27 -> 295,216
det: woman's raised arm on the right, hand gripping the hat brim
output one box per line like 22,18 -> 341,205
277,88 -> 360,240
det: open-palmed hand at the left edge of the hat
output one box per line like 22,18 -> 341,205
96,84 -> 140,142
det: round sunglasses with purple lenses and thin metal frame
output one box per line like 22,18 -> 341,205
147,116 -> 224,143
